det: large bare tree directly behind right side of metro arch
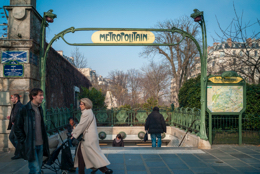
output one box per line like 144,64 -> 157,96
141,16 -> 200,107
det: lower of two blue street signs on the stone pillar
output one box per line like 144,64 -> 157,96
4,60 -> 24,77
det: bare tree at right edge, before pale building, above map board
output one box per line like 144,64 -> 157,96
214,4 -> 260,84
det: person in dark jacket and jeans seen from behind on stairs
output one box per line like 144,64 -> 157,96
145,107 -> 166,147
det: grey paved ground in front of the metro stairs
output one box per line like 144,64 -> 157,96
0,145 -> 260,174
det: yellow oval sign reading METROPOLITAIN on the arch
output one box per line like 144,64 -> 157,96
91,31 -> 155,43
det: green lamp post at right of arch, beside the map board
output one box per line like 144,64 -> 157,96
190,9 -> 208,140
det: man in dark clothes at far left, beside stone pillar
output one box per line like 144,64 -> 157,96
7,94 -> 23,160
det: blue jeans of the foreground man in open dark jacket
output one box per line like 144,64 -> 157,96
28,145 -> 43,174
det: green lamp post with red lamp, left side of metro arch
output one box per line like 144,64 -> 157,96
40,10 -> 57,115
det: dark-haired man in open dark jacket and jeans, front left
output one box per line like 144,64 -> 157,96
14,88 -> 50,174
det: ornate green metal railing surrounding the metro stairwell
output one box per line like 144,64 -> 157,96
46,106 -> 201,134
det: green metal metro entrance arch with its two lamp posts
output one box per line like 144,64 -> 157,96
40,9 -> 208,140
